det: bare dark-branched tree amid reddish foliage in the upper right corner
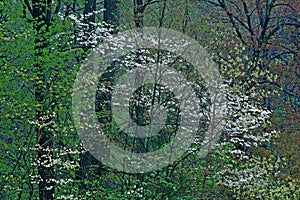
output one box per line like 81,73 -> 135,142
208,0 -> 300,132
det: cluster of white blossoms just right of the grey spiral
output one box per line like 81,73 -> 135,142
216,84 -> 276,193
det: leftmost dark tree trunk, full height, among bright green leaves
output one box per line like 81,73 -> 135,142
32,0 -> 54,200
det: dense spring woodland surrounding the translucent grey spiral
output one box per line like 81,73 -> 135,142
0,0 -> 300,200
